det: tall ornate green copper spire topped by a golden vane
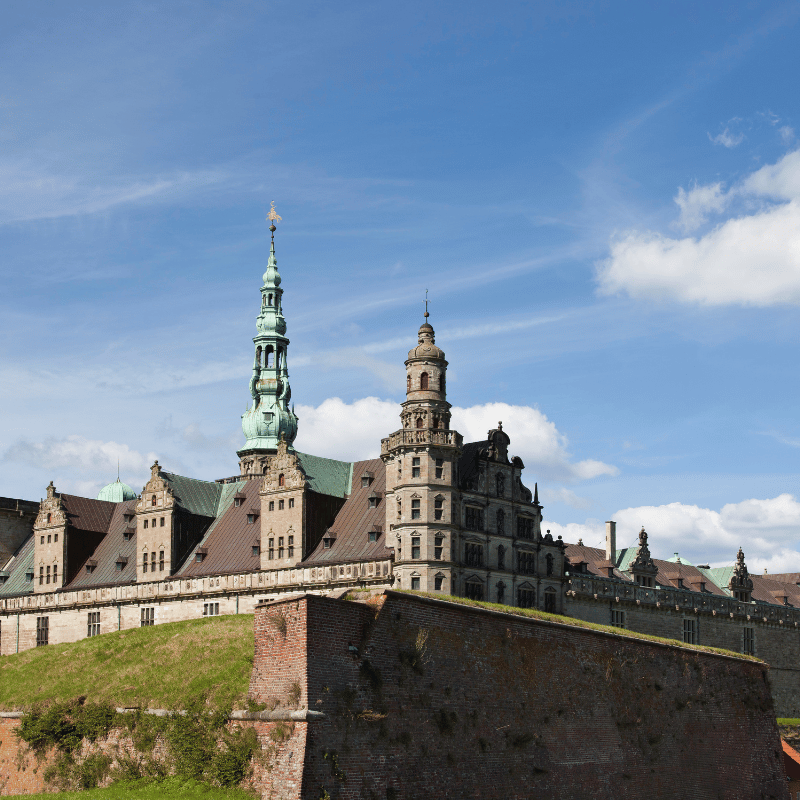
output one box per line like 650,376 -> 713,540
237,202 -> 297,475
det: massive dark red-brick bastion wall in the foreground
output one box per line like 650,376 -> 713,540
251,592 -> 788,800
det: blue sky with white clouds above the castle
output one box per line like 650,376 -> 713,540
0,0 -> 800,571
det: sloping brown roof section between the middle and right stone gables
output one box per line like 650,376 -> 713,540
175,477 -> 263,578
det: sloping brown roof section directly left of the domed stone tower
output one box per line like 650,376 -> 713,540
303,458 -> 393,566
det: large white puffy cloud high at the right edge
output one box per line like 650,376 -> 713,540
598,150 -> 800,306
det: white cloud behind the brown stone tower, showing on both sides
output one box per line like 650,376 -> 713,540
295,397 -> 619,482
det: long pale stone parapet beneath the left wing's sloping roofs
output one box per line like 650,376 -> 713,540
0,559 -> 392,615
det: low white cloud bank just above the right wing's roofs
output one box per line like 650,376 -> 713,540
545,494 -> 800,572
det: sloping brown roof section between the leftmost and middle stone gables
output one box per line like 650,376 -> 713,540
64,500 -> 137,591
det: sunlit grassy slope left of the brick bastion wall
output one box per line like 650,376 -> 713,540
0,614 -> 254,711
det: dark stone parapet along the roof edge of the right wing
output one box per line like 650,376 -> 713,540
567,574 -> 800,628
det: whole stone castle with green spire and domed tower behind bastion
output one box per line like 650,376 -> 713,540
0,215 -> 800,717
